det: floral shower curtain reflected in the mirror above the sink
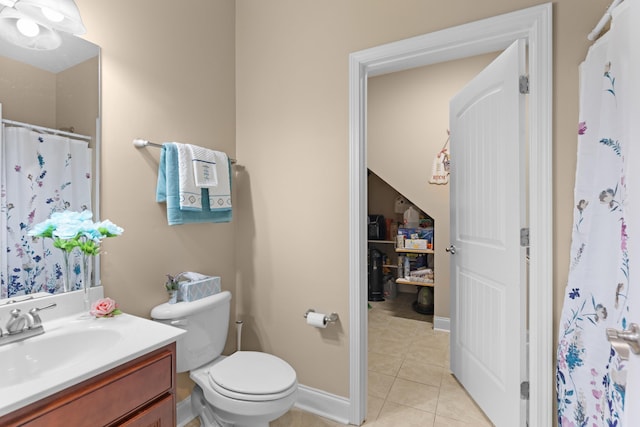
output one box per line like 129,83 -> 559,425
0,127 -> 92,298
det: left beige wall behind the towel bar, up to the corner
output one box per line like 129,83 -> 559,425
76,0 -> 237,397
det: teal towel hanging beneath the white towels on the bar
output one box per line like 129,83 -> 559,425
156,143 -> 232,225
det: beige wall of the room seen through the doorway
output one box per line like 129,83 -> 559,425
367,53 -> 496,318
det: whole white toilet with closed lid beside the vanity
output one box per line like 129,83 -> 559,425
151,291 -> 298,427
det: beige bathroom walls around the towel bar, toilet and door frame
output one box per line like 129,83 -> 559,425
70,0 -> 609,412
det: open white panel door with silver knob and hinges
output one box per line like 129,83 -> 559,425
449,41 -> 526,427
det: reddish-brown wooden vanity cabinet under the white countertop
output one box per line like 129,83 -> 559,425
0,343 -> 176,427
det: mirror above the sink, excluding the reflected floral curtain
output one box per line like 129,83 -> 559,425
0,33 -> 100,304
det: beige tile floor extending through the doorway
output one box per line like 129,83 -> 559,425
189,293 -> 492,427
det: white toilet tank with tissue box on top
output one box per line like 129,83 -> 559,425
151,291 -> 231,372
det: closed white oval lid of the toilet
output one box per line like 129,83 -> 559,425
209,351 -> 296,395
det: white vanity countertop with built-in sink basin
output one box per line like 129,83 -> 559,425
0,290 -> 185,416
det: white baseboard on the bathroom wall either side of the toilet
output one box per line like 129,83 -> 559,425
176,385 -> 350,427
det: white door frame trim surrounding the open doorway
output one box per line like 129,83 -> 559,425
349,3 -> 553,426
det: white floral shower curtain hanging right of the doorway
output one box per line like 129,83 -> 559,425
556,0 -> 640,427
